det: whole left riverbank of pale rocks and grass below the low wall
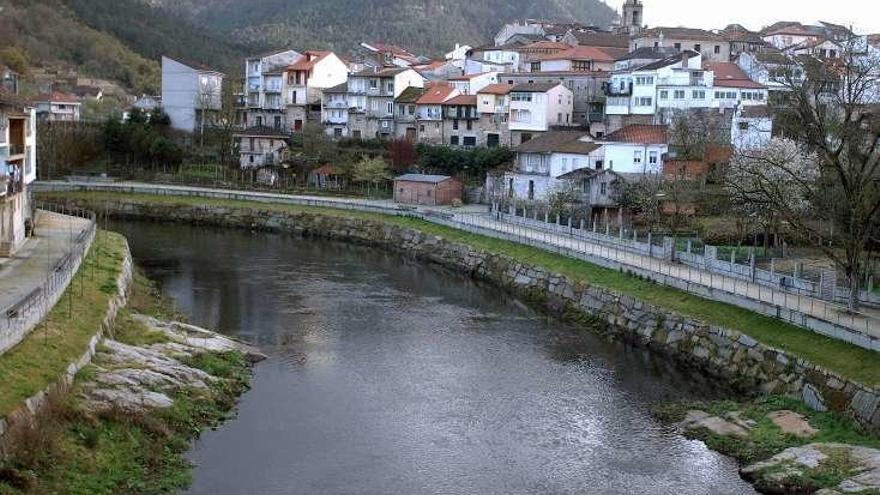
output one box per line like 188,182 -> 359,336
0,274 -> 265,495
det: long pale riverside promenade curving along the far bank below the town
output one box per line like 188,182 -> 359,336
34,181 -> 880,350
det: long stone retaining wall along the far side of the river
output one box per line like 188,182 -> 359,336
51,199 -> 880,433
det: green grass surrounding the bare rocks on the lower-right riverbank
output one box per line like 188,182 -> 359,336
653,396 -> 880,493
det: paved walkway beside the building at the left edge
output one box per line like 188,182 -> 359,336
0,211 -> 89,311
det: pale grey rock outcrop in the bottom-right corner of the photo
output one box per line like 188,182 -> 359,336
740,443 -> 880,495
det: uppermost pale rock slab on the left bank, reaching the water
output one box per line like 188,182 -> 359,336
132,315 -> 266,364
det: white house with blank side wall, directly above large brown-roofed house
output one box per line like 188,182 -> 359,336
509,83 -> 575,144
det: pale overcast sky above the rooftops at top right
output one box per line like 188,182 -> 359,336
605,0 -> 880,34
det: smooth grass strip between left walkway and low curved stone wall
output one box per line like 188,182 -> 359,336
0,232 -> 125,417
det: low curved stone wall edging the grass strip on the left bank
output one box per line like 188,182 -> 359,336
0,238 -> 134,458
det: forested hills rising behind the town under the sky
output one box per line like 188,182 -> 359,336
0,0 -> 615,93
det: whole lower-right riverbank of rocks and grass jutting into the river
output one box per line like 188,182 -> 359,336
654,397 -> 880,495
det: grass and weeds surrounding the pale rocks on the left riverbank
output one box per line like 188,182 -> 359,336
0,266 -> 250,495
